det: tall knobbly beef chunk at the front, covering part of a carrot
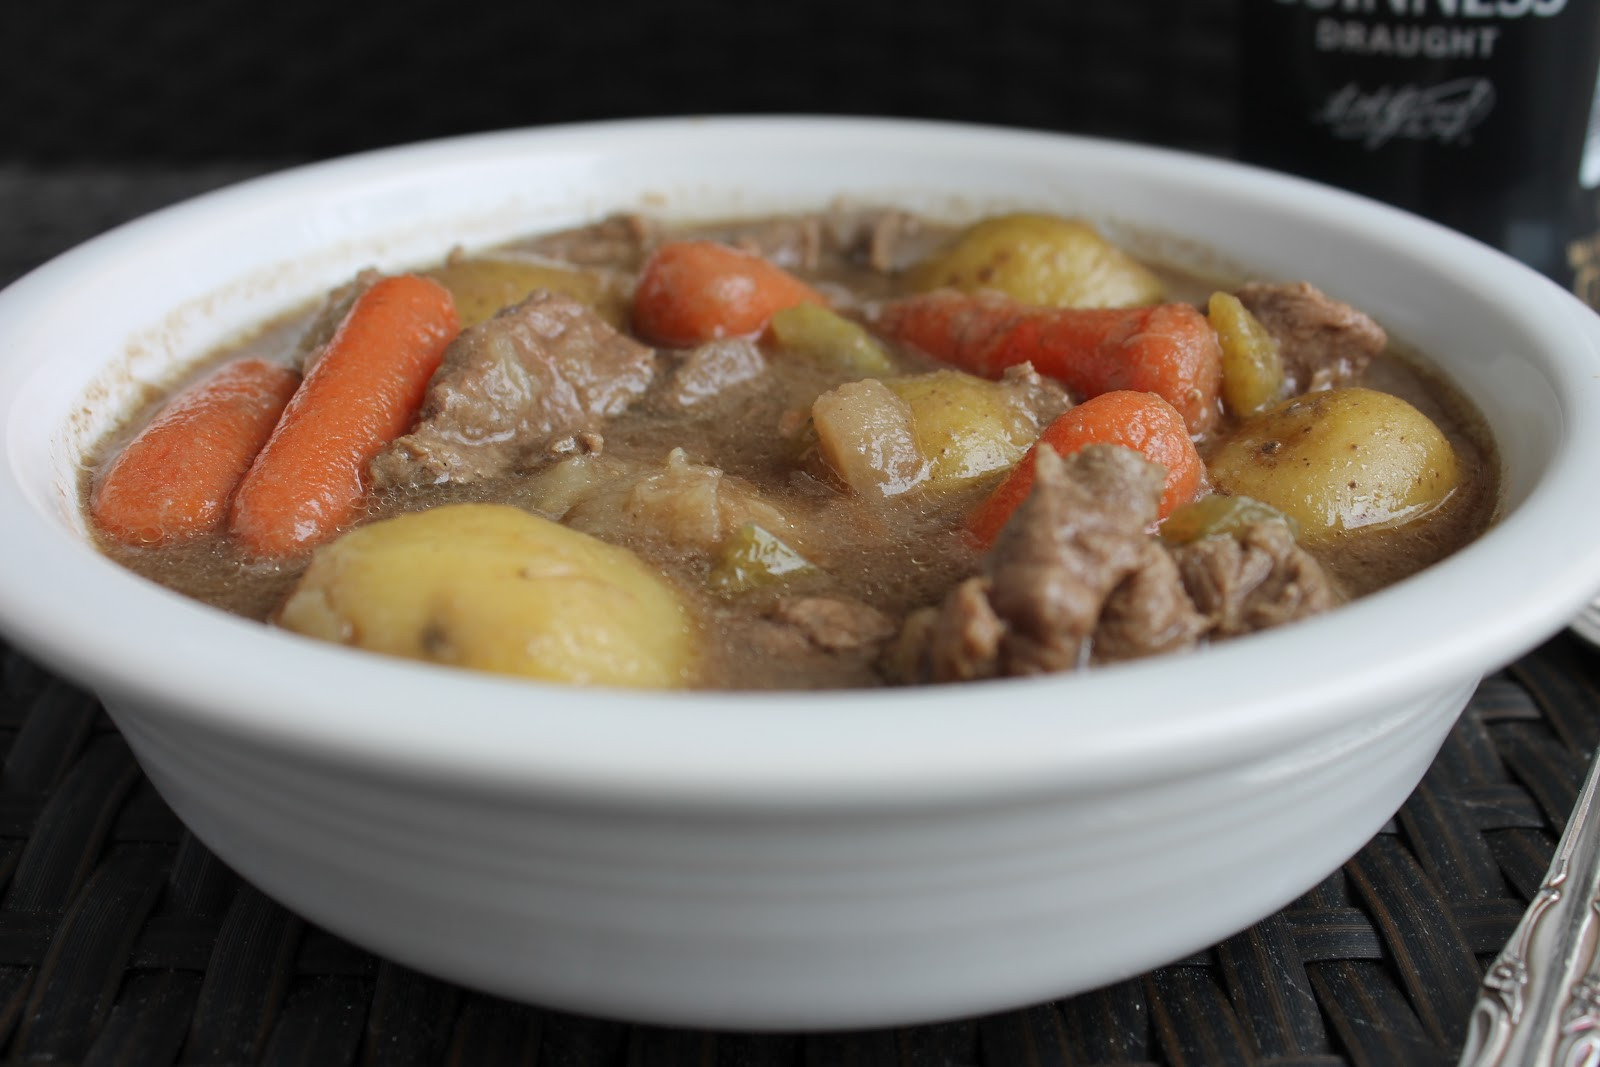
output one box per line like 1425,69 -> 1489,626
928,446 -> 1203,681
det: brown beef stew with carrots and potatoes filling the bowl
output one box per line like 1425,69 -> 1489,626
83,206 -> 1498,689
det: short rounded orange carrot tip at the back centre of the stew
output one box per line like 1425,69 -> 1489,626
634,240 -> 827,349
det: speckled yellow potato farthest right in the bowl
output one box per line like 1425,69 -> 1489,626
1210,389 -> 1461,542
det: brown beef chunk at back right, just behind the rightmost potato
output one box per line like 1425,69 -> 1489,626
1237,282 -> 1389,394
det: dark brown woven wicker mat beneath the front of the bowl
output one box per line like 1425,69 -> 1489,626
0,635 -> 1600,1067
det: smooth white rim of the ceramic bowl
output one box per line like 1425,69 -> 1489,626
9,115 -> 1600,808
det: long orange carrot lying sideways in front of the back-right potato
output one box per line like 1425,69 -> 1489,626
877,290 -> 1222,434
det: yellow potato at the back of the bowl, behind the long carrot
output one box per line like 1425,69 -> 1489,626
907,214 -> 1165,307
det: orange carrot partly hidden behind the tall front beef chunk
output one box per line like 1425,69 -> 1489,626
966,389 -> 1205,545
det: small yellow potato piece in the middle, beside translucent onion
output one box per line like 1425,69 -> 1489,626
883,371 -> 1038,493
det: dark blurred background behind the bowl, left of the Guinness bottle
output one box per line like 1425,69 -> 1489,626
0,0 -> 1237,166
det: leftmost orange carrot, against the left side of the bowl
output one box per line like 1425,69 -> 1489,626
90,360 -> 299,545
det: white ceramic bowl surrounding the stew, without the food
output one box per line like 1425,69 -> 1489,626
0,118 -> 1600,1027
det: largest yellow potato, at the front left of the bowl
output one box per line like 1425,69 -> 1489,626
277,504 -> 696,688
